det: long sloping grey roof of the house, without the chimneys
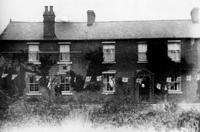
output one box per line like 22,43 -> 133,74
0,20 -> 200,40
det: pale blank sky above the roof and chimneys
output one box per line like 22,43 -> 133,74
0,0 -> 200,32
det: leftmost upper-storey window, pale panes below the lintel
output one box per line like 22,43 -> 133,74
28,44 -> 39,62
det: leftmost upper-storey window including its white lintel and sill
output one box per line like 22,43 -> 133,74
27,42 -> 41,64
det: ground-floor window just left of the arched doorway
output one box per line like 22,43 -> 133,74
103,71 -> 115,94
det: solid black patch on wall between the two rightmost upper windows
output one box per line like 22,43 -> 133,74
147,40 -> 193,95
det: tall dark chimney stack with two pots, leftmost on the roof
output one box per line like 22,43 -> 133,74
43,6 -> 55,39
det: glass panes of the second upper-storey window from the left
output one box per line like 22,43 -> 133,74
60,45 -> 70,61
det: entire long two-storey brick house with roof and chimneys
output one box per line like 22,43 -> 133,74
0,6 -> 200,102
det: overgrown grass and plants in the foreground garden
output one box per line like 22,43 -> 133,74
1,98 -> 200,132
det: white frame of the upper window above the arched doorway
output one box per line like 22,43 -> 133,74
137,41 -> 148,63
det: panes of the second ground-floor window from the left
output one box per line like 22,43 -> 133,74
60,75 -> 71,92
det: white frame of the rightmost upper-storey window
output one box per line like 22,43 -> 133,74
167,40 -> 181,63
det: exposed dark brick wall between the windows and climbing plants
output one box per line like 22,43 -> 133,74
0,39 -> 200,101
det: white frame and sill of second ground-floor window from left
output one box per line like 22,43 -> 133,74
60,74 -> 72,95
